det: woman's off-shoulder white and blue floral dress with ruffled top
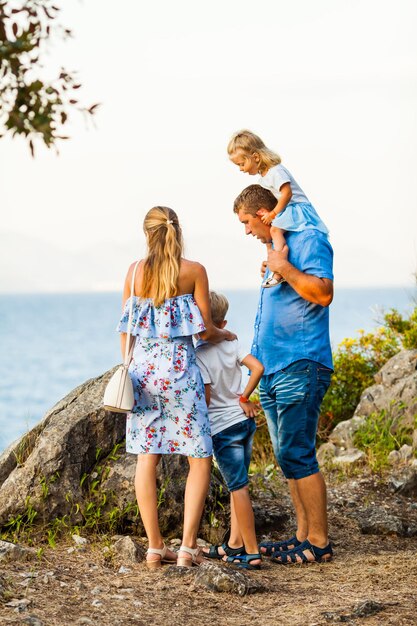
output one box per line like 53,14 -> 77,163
117,294 -> 212,457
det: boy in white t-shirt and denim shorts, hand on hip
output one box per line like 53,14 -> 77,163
196,291 -> 264,569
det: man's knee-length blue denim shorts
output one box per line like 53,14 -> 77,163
259,359 -> 332,479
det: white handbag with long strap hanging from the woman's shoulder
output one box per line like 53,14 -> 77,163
103,261 -> 139,413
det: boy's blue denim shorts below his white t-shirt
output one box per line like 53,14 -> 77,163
213,418 -> 256,491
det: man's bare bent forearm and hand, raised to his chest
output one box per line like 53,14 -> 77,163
267,244 -> 333,306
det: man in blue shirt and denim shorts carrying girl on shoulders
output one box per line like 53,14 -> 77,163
233,185 -> 333,564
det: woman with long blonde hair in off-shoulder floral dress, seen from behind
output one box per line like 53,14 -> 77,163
118,207 -> 235,566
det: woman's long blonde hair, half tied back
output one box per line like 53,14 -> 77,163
141,206 -> 184,306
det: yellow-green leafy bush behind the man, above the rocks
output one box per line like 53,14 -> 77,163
319,308 -> 417,441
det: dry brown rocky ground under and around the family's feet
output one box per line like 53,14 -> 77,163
0,475 -> 417,626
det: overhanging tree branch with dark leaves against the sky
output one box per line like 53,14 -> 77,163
0,0 -> 98,155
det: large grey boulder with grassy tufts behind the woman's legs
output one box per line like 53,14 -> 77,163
0,369 -> 228,540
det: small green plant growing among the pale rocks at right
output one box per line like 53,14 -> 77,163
353,404 -> 412,471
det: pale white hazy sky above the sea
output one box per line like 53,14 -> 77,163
0,0 -> 417,291
